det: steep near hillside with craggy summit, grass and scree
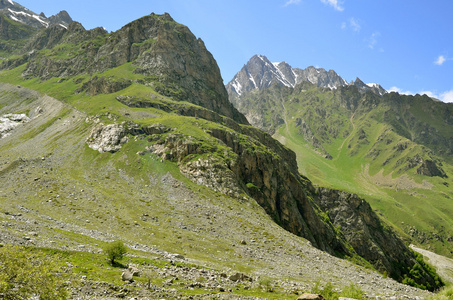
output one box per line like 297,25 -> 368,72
0,7 -> 442,297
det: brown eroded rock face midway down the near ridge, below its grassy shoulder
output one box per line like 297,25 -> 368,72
141,123 -> 350,254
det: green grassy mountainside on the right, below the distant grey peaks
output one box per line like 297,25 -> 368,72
228,72 -> 453,256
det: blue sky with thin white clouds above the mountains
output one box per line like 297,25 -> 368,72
17,0 -> 453,102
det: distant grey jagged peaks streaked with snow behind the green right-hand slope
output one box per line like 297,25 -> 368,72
226,55 -> 386,98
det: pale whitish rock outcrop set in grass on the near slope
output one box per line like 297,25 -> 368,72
87,124 -> 129,153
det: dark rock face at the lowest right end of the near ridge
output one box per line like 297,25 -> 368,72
315,188 -> 435,286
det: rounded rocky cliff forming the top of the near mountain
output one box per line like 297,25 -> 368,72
2,14 -> 247,123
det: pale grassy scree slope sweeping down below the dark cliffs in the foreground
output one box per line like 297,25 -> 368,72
0,82 -> 438,299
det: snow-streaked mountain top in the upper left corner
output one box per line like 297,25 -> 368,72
0,0 -> 72,29
